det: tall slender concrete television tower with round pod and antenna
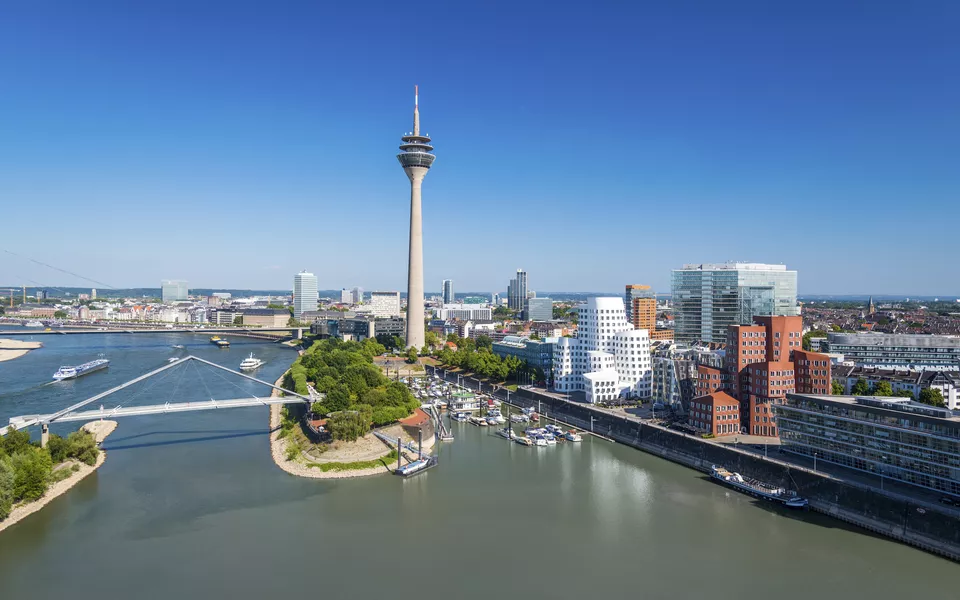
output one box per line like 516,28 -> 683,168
397,86 -> 436,350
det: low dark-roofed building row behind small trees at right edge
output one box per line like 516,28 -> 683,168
828,365 -> 960,410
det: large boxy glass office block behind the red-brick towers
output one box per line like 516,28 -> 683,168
672,263 -> 800,344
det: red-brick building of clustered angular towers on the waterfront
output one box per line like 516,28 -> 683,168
725,316 -> 831,437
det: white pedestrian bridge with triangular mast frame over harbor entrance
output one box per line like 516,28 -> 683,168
0,355 -> 313,446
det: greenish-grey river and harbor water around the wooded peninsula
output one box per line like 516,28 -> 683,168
0,334 -> 960,600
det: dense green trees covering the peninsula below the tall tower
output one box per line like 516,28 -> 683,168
284,338 -> 420,440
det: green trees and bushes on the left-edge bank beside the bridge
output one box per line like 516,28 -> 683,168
0,430 -> 99,521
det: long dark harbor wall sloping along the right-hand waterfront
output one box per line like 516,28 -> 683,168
510,389 -> 960,561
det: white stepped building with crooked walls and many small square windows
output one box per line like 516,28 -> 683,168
553,298 -> 651,403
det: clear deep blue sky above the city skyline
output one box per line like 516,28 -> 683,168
0,0 -> 960,295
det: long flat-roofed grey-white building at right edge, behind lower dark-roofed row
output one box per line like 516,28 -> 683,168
826,333 -> 960,371
